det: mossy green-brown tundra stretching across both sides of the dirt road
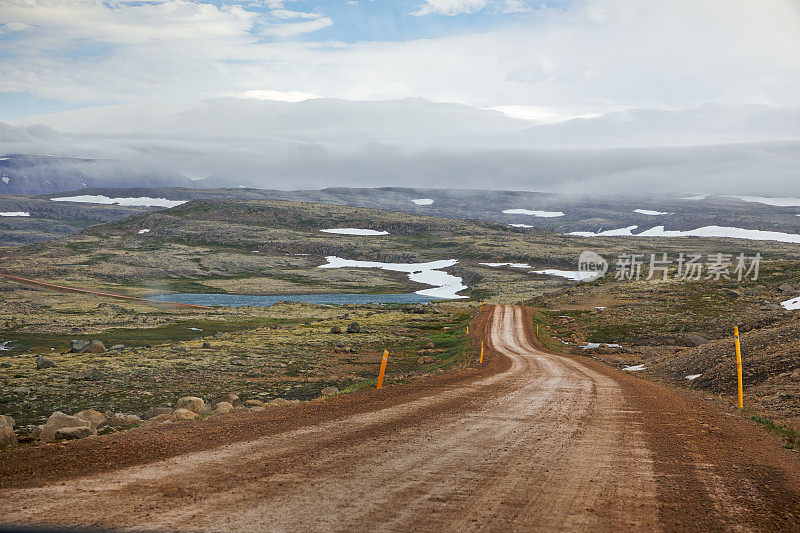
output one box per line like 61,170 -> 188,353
0,197 -> 800,442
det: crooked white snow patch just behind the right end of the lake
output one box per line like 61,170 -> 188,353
317,255 -> 467,299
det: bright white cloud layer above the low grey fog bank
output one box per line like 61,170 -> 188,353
0,0 -> 800,114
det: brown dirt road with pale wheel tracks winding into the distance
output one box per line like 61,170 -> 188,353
0,306 -> 800,531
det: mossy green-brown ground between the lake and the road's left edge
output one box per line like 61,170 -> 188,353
0,300 -> 478,426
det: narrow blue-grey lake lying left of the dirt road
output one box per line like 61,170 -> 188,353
147,293 -> 441,307
